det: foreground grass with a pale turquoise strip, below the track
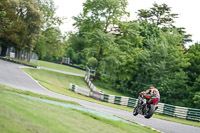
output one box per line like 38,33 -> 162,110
0,85 -> 155,133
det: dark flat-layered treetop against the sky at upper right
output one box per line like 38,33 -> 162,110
138,3 -> 192,44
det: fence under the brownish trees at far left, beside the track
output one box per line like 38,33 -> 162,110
6,47 -> 38,64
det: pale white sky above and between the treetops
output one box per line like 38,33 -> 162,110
54,0 -> 200,43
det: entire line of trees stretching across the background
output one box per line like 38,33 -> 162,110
0,0 -> 200,108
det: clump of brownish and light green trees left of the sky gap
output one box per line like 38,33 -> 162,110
0,0 -> 67,60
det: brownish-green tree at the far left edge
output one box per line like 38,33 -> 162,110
0,0 -> 42,55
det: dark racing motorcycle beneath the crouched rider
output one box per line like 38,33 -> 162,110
133,95 -> 158,119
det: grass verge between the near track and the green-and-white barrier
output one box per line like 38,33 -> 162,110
23,69 -> 200,127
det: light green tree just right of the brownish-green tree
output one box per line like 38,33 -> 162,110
34,0 -> 66,61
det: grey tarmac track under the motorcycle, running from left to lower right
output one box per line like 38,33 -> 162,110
0,60 -> 200,133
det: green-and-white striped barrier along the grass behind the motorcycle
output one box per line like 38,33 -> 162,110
70,76 -> 200,122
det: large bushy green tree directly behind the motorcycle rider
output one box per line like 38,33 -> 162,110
120,31 -> 189,105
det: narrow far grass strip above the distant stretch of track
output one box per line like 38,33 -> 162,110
37,60 -> 86,74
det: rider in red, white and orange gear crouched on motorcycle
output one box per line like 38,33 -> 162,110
139,87 -> 160,109
